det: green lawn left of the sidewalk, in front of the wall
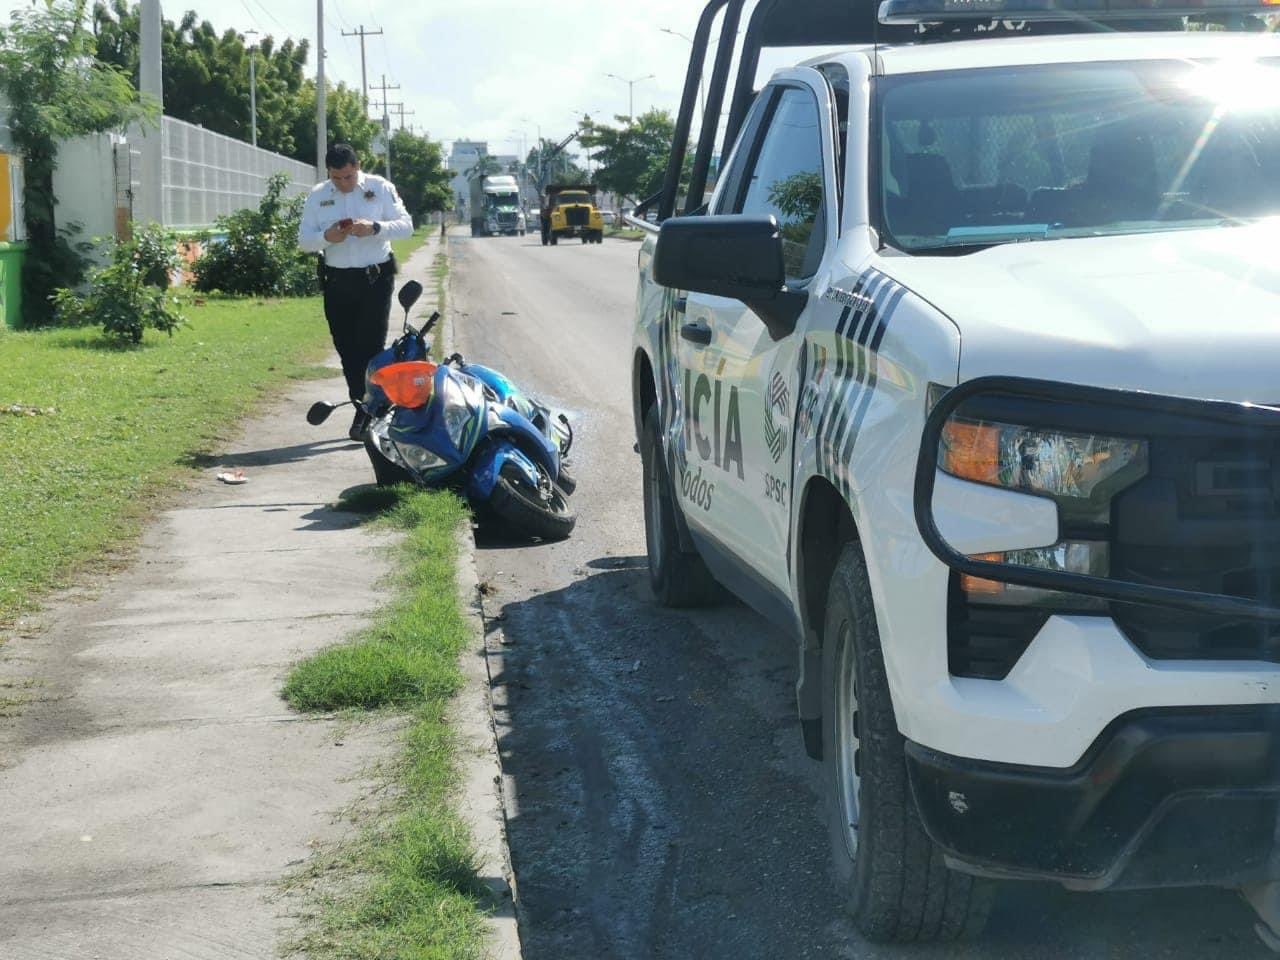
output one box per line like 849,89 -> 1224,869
0,297 -> 334,625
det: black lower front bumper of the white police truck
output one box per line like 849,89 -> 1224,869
906,705 -> 1280,890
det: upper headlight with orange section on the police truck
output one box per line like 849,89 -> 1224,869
938,416 -> 1147,500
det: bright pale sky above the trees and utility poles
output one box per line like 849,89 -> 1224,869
30,0 -> 727,163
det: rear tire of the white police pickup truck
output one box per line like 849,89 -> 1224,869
640,406 -> 723,608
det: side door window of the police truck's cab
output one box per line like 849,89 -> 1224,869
732,87 -> 826,280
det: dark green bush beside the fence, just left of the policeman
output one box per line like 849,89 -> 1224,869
192,173 -> 320,297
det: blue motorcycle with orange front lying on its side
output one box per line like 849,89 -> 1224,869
307,280 -> 577,540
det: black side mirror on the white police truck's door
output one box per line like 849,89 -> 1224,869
653,216 -> 805,340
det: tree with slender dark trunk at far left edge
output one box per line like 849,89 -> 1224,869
0,0 -> 159,325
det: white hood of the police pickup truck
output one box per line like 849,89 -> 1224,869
877,220 -> 1280,403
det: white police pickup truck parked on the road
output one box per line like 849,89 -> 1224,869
630,0 -> 1280,940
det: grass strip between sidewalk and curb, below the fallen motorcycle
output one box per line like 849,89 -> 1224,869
284,486 -> 490,960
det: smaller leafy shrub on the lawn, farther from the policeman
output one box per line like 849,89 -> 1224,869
50,224 -> 184,343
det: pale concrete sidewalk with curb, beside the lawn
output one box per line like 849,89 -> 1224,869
0,237 -> 518,960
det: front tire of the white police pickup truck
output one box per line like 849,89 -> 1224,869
822,543 -> 993,943
